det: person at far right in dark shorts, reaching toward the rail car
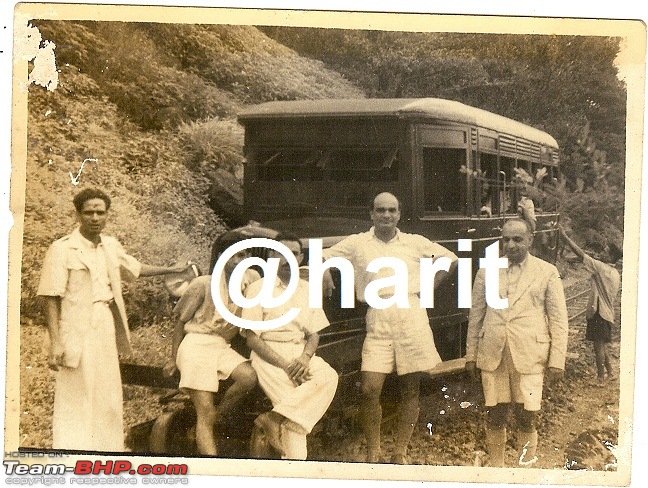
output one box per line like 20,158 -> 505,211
560,227 -> 621,383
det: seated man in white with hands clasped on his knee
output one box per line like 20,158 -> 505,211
242,235 -> 338,460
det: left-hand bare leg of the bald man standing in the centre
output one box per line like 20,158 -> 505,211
360,371 -> 387,463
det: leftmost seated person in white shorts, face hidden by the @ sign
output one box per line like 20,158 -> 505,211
164,237 -> 260,456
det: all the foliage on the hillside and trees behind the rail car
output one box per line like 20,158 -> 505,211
22,21 -> 626,324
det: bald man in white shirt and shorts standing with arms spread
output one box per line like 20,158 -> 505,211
323,193 -> 457,464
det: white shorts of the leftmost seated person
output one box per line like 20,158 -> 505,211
176,334 -> 247,392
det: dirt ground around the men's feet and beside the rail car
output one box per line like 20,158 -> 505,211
20,264 -> 620,469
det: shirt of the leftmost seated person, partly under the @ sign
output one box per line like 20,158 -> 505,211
173,269 -> 260,341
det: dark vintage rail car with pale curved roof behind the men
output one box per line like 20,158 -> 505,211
124,98 -> 560,452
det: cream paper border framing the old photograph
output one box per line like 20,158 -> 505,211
5,3 -> 645,485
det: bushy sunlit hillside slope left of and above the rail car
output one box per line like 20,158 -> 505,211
21,21 -> 364,326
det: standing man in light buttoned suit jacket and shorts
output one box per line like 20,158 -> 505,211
466,218 -> 568,467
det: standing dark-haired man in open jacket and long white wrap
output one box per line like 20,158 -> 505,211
38,188 -> 187,451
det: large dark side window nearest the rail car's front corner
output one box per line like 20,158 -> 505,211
423,147 -> 466,212
